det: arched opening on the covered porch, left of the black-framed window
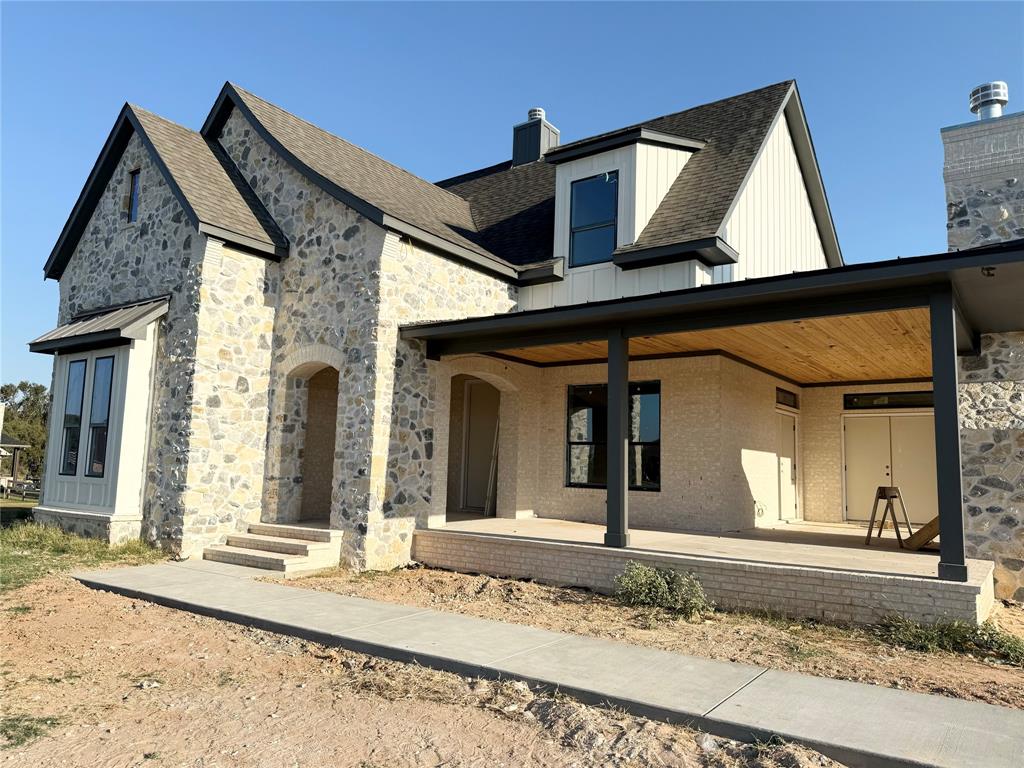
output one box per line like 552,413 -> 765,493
446,375 -> 502,519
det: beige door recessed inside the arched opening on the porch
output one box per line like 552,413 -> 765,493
462,381 -> 501,515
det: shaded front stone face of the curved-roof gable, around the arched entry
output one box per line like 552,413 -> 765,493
219,111 -> 385,566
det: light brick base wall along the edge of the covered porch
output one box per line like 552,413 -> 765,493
413,530 -> 992,624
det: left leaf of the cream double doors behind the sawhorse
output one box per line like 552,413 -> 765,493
843,416 -> 892,521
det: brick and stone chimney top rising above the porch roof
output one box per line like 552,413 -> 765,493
942,113 -> 1024,251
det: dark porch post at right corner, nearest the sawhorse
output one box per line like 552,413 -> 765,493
929,288 -> 967,582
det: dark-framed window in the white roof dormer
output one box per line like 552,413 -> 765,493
569,171 -> 618,266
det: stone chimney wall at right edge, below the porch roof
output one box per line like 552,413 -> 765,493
959,333 -> 1024,600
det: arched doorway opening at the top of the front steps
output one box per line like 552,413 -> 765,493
298,366 -> 338,521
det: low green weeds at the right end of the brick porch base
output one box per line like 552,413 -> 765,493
874,616 -> 1024,667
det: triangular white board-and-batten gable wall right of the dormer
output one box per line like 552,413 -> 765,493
713,114 -> 828,283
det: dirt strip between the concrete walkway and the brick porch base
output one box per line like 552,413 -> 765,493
290,568 -> 1024,709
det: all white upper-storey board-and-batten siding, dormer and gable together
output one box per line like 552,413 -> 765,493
519,116 -> 827,310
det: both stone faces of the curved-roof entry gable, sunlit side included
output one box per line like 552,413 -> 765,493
220,111 -> 516,568
